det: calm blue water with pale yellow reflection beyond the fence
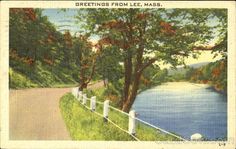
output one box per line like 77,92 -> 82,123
132,82 -> 227,140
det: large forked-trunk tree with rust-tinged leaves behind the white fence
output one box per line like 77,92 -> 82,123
77,9 -> 226,112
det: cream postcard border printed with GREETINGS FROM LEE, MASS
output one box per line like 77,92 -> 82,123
0,1 -> 236,149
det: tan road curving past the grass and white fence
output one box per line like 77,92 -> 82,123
9,82 -> 102,140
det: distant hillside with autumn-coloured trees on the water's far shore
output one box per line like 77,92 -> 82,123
168,59 -> 227,94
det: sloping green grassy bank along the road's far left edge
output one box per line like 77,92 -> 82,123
9,62 -> 78,89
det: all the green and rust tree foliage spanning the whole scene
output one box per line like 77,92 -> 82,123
9,8 -> 227,106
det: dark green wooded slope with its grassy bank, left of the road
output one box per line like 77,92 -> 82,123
9,8 -> 94,88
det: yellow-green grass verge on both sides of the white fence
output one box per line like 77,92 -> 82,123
60,93 -> 182,141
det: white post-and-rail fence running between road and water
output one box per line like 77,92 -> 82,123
72,87 -> 202,141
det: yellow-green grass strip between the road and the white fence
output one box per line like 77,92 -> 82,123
60,94 -> 134,140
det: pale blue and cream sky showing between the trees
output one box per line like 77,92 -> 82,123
42,9 -> 221,68
